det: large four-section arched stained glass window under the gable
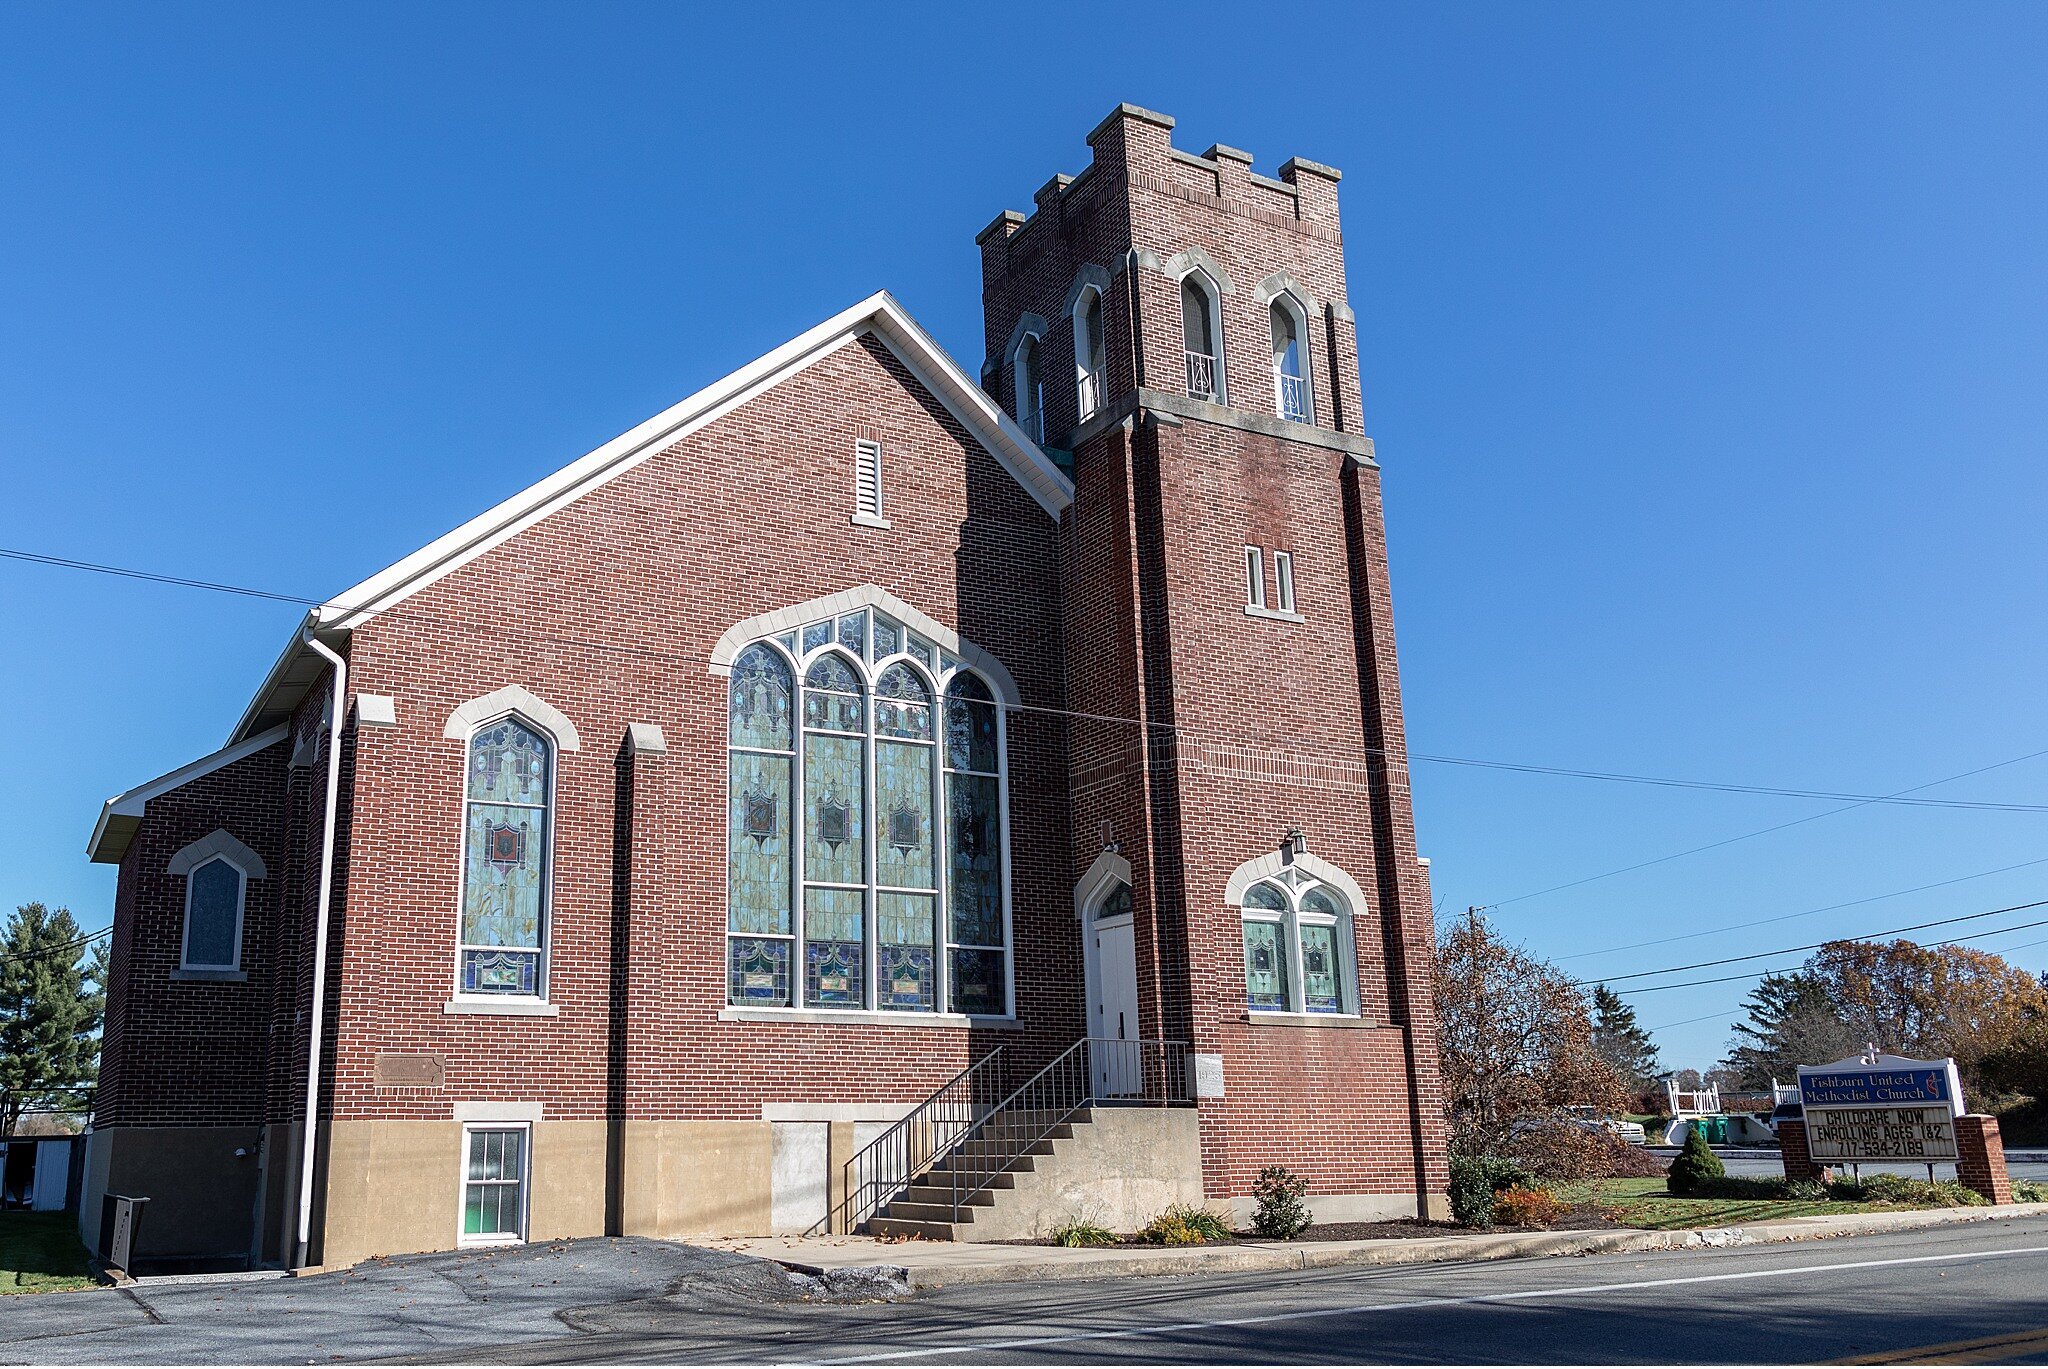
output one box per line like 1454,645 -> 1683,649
727,609 -> 1010,1014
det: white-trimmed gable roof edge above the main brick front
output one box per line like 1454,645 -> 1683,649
227,291 -> 1073,744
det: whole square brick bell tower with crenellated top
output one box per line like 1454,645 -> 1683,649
977,105 -> 1448,1221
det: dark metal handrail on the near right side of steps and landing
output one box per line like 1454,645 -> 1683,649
942,1037 -> 1194,1221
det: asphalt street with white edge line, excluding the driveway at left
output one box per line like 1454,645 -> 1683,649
432,1219 -> 2048,1365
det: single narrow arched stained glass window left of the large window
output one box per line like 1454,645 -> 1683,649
457,717 -> 553,996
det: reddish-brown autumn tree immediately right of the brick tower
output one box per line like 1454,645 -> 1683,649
1436,916 -> 1626,1154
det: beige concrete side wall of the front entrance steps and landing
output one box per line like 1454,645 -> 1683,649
958,1107 -> 1202,1240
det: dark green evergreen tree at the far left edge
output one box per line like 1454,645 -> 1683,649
0,904 -> 106,1135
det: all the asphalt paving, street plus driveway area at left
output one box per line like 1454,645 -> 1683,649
12,1217 -> 2048,1365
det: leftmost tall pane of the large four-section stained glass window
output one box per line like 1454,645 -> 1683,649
727,641 -> 797,1006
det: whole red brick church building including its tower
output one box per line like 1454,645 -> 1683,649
82,105 -> 1446,1267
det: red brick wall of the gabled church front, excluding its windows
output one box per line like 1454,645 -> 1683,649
334,338 -> 1081,1117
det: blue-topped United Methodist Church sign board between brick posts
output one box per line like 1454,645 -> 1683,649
1798,1053 -> 1962,1162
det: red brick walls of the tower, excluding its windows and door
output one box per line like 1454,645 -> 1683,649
983,104 -> 1448,1195
